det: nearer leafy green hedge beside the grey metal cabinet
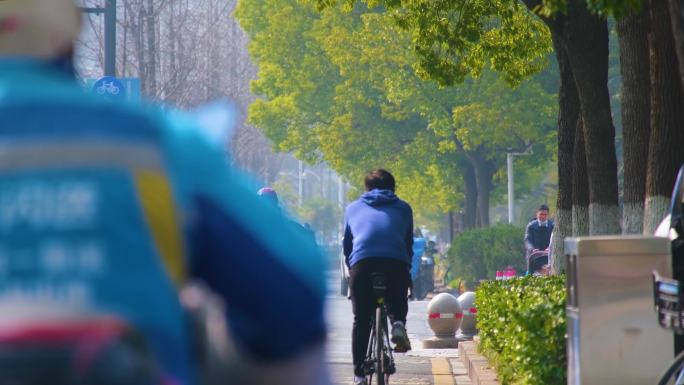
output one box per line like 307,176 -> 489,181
475,276 -> 566,385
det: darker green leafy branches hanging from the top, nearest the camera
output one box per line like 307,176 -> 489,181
324,0 -> 551,85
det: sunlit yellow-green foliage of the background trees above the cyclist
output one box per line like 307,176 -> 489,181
236,0 -> 555,220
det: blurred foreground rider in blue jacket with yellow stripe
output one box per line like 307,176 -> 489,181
0,0 -> 327,385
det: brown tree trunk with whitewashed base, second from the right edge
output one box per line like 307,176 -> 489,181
617,4 -> 651,234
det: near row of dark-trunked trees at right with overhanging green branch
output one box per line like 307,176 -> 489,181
306,0 -> 684,268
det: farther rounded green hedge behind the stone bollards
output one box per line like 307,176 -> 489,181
448,224 -> 525,287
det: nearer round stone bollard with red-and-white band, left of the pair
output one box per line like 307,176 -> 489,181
423,293 -> 463,349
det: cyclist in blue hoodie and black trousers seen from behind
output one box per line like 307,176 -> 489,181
343,169 -> 413,384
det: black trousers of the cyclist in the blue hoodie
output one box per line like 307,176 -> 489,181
349,258 -> 411,376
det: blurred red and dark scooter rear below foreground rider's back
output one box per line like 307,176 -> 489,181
0,301 -> 164,385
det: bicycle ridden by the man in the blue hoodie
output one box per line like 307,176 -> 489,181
364,273 -> 396,385
